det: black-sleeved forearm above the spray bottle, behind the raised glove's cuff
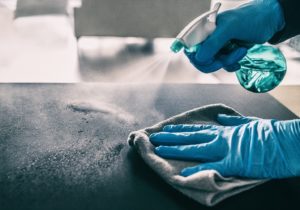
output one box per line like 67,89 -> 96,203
269,0 -> 300,44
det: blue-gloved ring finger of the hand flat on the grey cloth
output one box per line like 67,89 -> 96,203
154,142 -> 225,161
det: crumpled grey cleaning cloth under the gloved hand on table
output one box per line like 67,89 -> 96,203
128,104 -> 265,206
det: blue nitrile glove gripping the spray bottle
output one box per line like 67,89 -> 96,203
185,0 -> 285,73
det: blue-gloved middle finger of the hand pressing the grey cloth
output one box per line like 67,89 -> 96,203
149,130 -> 217,146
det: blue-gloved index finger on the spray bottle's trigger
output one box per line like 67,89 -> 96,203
195,21 -> 230,65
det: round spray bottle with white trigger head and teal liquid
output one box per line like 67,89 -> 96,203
171,3 -> 286,93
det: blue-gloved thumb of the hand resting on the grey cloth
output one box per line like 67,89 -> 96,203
217,114 -> 259,126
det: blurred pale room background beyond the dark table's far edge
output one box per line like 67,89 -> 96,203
0,0 -> 300,85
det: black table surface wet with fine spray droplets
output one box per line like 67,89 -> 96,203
0,83 -> 300,210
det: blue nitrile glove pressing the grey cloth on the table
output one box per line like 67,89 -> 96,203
150,114 -> 300,179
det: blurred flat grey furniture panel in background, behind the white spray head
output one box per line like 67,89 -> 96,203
75,0 -> 210,38
